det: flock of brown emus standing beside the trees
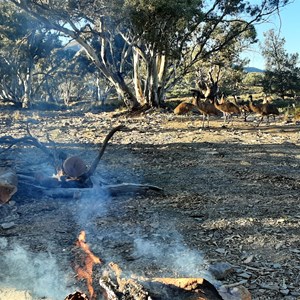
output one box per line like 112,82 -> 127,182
174,93 -> 279,128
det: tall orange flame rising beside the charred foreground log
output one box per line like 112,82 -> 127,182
75,231 -> 102,299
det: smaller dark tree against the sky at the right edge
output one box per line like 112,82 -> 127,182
262,30 -> 300,98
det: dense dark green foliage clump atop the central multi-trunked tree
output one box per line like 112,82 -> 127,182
122,0 -> 202,54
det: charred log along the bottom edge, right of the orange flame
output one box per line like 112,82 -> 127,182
99,272 -> 251,300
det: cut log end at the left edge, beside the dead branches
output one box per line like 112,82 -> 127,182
0,169 -> 18,204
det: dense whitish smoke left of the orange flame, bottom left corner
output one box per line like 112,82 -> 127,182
0,240 -> 70,299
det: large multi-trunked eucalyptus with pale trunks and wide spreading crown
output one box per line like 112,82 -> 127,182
7,0 -> 289,109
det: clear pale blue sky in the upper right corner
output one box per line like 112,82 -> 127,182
243,0 -> 300,69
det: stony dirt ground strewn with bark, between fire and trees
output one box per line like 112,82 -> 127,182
0,109 -> 300,300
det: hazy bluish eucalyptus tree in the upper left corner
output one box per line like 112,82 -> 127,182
0,2 -> 61,107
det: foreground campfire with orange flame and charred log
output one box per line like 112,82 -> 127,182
65,231 -> 251,300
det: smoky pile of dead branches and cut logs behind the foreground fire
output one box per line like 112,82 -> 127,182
0,125 -> 162,204
